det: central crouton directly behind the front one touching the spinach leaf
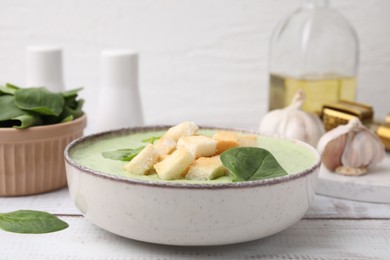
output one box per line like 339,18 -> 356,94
177,135 -> 217,159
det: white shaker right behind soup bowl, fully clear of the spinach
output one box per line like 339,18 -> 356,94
94,49 -> 144,131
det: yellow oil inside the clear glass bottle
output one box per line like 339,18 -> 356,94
269,74 -> 356,114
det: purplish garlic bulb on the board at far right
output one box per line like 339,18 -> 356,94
317,118 -> 385,175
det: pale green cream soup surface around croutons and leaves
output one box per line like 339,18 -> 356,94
69,129 -> 317,183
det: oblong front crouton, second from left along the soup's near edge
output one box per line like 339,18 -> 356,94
154,148 -> 194,180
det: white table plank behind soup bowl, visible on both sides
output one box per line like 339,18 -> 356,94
0,189 -> 390,219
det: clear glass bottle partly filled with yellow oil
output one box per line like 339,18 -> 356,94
269,0 -> 359,114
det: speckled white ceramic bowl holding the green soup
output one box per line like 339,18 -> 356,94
65,127 -> 320,246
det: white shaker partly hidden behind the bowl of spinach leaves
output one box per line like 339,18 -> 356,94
26,46 -> 65,92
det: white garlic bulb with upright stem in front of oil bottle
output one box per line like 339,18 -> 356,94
259,90 -> 325,147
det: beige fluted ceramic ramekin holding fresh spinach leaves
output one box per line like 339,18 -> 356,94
0,115 -> 87,196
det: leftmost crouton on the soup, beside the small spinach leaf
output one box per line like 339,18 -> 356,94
124,144 -> 158,175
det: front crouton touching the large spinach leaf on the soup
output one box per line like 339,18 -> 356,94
185,156 -> 226,180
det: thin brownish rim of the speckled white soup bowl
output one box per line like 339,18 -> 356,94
64,125 -> 321,189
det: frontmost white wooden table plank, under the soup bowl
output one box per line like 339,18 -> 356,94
0,216 -> 390,260
